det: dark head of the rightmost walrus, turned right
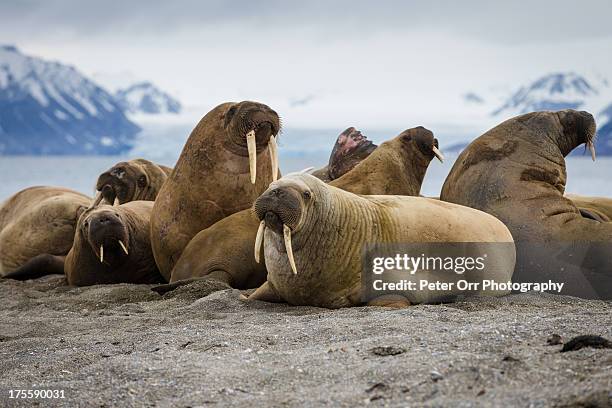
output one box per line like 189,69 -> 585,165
555,109 -> 597,161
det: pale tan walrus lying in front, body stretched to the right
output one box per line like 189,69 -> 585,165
248,174 -> 515,308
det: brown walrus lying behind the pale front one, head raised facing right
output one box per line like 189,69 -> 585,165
156,127 -> 442,293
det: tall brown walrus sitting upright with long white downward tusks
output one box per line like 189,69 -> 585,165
151,101 -> 280,279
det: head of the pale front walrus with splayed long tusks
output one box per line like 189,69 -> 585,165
253,174 -> 323,274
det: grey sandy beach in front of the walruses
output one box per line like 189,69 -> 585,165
0,275 -> 612,407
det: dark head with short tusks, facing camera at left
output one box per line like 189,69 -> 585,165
78,205 -> 130,265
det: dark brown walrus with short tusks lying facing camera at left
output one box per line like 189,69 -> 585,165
64,201 -> 165,286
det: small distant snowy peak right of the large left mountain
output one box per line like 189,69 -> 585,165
115,82 -> 181,114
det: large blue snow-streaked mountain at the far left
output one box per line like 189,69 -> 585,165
0,46 -> 140,155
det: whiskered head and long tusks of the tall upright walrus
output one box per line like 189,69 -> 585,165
223,101 -> 281,184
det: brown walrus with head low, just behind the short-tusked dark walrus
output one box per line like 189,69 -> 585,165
96,159 -> 172,205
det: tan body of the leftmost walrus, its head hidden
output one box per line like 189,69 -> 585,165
0,186 -> 92,277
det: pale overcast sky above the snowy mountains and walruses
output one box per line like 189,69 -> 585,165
0,0 -> 612,132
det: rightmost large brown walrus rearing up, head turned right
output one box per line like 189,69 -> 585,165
440,110 -> 612,299
